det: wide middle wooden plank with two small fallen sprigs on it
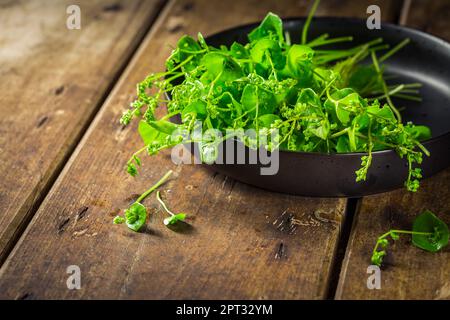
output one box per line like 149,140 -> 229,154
0,0 -> 400,299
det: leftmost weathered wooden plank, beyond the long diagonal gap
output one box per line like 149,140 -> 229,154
0,0 -> 162,263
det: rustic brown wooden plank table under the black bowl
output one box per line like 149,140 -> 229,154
0,0 -> 450,299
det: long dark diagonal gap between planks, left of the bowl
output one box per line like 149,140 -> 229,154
0,0 -> 173,268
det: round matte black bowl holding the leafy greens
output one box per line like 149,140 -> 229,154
171,18 -> 450,197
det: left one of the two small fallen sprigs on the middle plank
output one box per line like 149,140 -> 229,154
113,170 -> 173,232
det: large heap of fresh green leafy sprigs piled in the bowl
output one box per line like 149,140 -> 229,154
121,1 -> 431,192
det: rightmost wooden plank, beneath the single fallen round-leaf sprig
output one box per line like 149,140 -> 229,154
336,0 -> 450,299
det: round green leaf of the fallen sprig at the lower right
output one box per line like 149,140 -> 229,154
412,210 -> 449,252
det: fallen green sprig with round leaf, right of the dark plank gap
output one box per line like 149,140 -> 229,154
371,210 -> 449,266
